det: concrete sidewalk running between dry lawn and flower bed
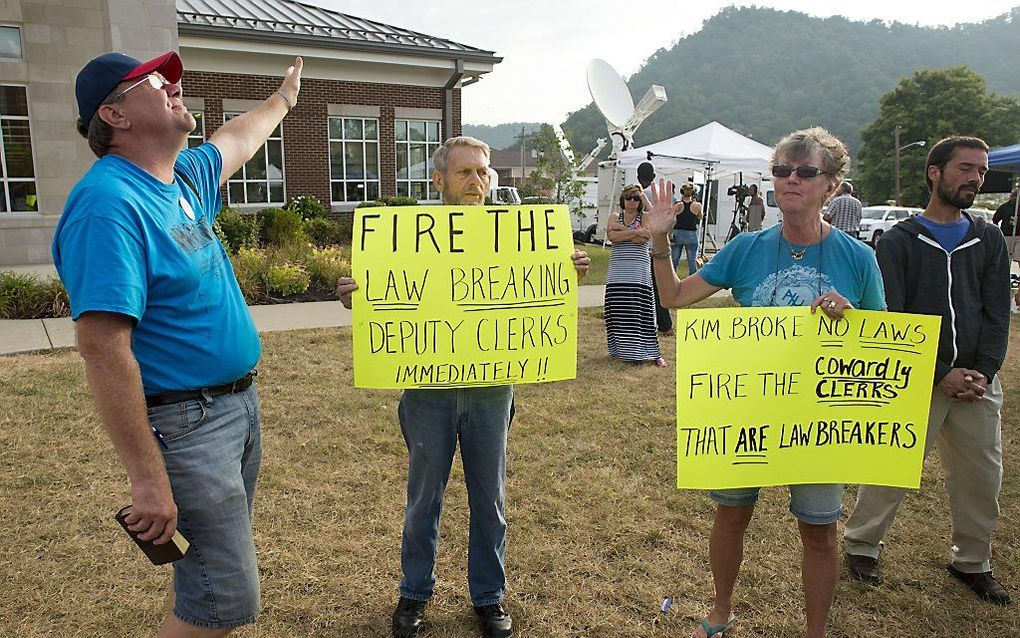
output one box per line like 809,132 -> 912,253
0,286 -> 606,354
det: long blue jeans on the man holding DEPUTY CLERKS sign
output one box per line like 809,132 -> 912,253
397,386 -> 513,606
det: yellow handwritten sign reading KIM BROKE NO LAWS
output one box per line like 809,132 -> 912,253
676,307 -> 940,489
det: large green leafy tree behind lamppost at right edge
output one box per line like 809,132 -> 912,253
857,66 -> 1020,206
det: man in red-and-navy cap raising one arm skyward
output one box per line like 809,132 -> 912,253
53,51 -> 302,637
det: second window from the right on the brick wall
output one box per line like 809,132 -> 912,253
329,117 -> 379,203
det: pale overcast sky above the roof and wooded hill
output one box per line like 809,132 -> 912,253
314,0 -> 1020,125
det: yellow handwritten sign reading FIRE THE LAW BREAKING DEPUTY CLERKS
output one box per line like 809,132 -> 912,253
351,205 -> 577,388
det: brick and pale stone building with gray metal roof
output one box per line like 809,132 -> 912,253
0,0 -> 501,266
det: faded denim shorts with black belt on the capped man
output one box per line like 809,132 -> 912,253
149,385 -> 262,629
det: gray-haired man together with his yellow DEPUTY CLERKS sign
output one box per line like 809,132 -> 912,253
339,137 -> 591,638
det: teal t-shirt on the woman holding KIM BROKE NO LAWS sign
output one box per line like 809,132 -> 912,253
698,226 -> 885,310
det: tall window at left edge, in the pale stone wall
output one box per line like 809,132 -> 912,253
0,85 -> 39,212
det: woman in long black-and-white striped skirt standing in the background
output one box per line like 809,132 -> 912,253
605,184 -> 666,366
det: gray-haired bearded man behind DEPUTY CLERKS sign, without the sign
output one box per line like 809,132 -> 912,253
339,137 -> 591,638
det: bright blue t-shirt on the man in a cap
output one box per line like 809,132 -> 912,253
53,144 -> 261,395
